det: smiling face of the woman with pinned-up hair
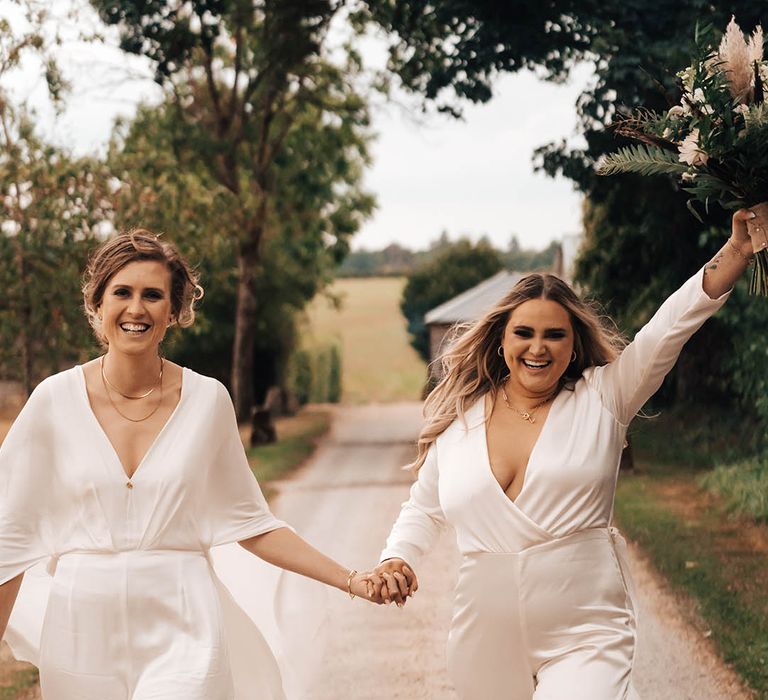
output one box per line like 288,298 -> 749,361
98,260 -> 171,355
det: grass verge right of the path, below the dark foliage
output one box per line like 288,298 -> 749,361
615,414 -> 768,700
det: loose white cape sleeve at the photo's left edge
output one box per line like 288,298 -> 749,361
0,383 -> 55,583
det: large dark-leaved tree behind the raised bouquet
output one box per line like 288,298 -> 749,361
368,0 -> 768,418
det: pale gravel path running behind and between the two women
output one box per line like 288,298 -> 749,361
274,404 -> 751,700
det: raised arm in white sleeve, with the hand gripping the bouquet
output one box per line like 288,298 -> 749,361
584,209 -> 754,424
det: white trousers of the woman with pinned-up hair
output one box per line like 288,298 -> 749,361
40,550 -> 235,700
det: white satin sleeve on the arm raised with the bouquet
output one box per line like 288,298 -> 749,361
584,268 -> 730,425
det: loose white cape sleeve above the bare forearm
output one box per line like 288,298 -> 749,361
201,382 -> 288,546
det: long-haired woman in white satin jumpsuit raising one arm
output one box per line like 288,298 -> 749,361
376,210 -> 753,700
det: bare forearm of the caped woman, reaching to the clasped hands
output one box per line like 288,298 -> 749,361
240,527 -> 350,591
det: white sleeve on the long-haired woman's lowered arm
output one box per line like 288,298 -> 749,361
379,443 -> 445,569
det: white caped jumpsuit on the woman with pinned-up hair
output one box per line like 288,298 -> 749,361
0,366 -> 285,700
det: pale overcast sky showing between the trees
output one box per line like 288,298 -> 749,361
0,0 -> 591,254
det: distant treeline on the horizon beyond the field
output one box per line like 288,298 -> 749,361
336,233 -> 560,277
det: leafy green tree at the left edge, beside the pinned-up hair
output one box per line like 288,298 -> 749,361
0,103 -> 111,393
